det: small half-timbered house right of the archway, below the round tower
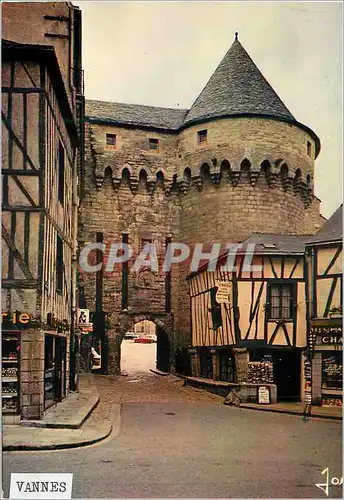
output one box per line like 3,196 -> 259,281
189,233 -> 309,401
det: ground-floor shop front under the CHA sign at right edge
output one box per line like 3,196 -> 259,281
311,318 -> 343,406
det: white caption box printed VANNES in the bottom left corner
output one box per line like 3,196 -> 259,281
10,473 -> 73,500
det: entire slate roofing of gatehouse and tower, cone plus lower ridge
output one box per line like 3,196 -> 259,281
85,38 -> 320,157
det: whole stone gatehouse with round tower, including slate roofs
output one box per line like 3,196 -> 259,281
79,36 -> 323,373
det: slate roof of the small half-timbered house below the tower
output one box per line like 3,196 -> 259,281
238,233 -> 310,255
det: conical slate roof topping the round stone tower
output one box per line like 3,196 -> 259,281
184,34 -> 296,124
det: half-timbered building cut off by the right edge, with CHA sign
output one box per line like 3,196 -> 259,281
306,206 -> 343,406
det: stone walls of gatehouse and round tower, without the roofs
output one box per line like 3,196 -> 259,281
79,113 -> 323,372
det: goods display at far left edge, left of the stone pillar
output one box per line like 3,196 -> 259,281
2,334 -> 20,414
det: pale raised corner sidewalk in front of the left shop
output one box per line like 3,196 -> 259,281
2,375 -> 120,451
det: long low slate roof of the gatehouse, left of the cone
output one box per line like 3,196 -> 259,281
85,100 -> 187,130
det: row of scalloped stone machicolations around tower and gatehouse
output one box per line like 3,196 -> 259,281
90,158 -> 314,208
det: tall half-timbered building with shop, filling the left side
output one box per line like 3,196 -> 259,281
2,2 -> 84,419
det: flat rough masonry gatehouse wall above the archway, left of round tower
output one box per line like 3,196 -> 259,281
79,125 -> 180,348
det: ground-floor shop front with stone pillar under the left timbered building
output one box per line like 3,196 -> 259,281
1,325 -> 69,418
